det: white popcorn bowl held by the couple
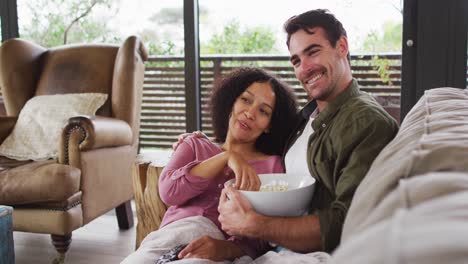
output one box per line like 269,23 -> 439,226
225,173 -> 315,216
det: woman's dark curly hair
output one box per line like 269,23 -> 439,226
210,67 -> 297,155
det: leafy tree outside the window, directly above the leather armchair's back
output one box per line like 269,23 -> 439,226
20,0 -> 120,47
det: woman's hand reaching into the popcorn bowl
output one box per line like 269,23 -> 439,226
227,152 -> 261,191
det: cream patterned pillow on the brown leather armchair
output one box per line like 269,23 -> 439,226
0,93 -> 107,160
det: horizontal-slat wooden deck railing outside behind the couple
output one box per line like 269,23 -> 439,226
140,54 -> 401,151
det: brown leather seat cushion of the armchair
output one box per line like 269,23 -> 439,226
0,157 -> 81,205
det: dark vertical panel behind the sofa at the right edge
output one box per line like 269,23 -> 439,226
401,0 -> 468,120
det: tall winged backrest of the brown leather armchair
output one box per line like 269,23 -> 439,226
0,36 -> 147,148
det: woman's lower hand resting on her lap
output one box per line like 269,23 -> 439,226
178,236 -> 243,261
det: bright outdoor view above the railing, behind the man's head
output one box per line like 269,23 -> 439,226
198,0 -> 403,55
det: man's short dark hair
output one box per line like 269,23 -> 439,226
284,9 -> 350,61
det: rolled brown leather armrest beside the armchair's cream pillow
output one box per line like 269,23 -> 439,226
59,115 -> 133,165
